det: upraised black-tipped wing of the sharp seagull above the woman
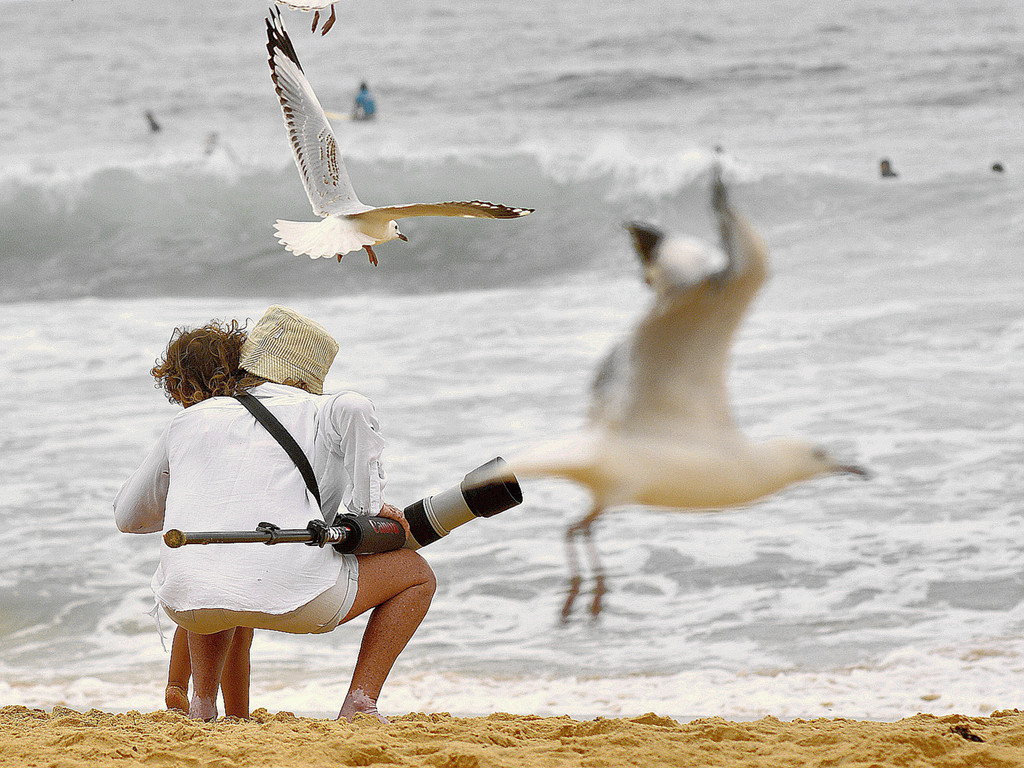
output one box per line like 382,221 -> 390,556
266,9 -> 368,216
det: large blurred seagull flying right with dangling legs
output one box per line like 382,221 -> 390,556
510,165 -> 867,621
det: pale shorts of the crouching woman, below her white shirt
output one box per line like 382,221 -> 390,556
163,555 -> 359,635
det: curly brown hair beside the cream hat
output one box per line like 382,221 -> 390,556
150,319 -> 266,408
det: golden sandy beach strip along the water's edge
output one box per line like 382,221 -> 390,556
0,707 -> 1024,768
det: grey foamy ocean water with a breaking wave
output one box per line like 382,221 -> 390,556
0,0 -> 1024,719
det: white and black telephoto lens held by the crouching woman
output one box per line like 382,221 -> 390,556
403,457 -> 522,549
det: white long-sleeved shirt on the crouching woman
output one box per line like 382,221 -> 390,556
114,383 -> 386,613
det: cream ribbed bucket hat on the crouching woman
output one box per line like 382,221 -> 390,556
239,304 -> 338,394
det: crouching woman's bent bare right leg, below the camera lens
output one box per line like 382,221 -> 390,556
338,549 -> 437,723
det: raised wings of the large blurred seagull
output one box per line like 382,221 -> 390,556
591,173 -> 768,439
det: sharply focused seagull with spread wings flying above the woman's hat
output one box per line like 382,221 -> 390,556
266,9 -> 534,264
